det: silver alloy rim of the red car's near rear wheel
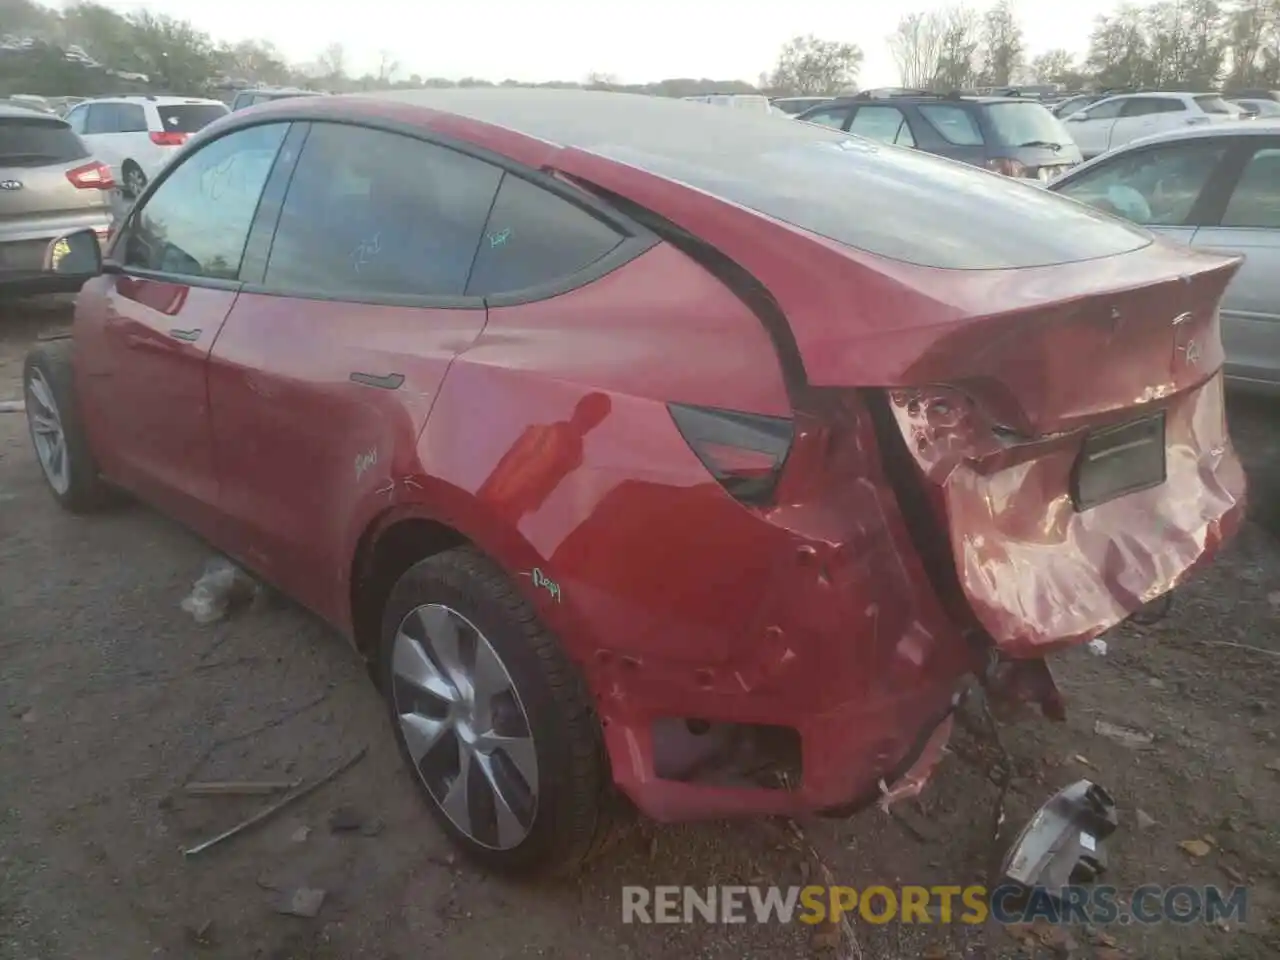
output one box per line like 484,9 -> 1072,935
390,603 -> 538,850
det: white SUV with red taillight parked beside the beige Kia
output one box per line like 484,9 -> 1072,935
67,96 -> 228,196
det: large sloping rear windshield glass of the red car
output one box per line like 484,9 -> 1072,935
593,131 -> 1152,270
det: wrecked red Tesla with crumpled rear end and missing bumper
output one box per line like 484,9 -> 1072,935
26,90 -> 1244,870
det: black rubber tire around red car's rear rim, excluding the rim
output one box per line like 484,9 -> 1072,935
378,547 -> 617,877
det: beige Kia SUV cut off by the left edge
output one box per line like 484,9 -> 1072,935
0,106 -> 115,293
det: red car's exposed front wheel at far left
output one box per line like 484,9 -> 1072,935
22,339 -> 110,513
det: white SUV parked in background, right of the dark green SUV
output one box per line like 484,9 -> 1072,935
1066,92 -> 1240,159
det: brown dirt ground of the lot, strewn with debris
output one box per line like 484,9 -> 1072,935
0,296 -> 1280,960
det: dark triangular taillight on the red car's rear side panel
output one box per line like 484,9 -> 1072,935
667,403 -> 795,503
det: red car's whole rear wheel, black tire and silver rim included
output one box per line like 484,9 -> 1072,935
380,548 -> 612,874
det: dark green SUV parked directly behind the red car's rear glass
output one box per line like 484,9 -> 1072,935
796,91 -> 1083,180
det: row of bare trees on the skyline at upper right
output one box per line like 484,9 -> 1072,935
888,0 -> 1280,90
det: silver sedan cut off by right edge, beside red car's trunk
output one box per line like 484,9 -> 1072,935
1048,120 -> 1280,392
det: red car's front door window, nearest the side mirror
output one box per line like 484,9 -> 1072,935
124,123 -> 288,280
